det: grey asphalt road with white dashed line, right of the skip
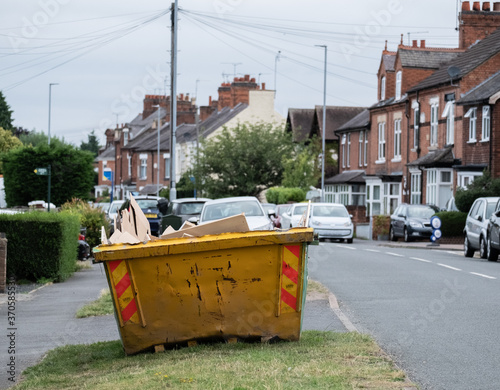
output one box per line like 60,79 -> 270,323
309,240 -> 500,390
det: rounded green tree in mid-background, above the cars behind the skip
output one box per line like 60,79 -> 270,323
191,123 -> 294,198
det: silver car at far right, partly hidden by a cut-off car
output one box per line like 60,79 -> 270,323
464,196 -> 500,259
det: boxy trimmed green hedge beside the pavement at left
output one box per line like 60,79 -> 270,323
0,211 -> 80,282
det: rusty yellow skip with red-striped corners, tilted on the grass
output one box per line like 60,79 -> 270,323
94,228 -> 313,354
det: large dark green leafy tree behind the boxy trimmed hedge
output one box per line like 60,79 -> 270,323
2,143 -> 94,207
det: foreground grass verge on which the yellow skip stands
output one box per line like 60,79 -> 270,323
14,331 -> 410,390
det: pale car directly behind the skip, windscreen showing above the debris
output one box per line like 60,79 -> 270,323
198,196 -> 273,230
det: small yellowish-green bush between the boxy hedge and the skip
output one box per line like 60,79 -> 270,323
61,199 -> 109,248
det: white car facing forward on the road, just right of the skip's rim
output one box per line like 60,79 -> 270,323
309,203 -> 354,244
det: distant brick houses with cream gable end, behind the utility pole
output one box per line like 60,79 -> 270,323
95,75 -> 284,199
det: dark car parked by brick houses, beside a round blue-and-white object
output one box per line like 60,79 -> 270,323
389,203 -> 439,242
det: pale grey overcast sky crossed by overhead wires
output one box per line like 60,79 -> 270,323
0,0 -> 458,146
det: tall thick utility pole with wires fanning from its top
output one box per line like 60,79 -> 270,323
170,0 -> 178,201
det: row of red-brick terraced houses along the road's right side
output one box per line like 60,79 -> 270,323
332,1 -> 500,216
